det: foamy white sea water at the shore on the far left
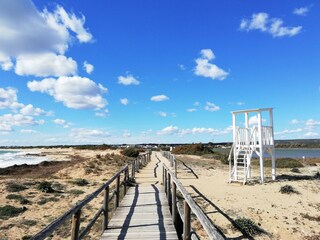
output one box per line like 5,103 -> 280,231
0,150 -> 48,168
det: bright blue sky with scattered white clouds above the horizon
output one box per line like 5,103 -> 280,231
0,0 -> 320,145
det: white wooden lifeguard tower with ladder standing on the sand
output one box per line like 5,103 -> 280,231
229,108 -> 276,184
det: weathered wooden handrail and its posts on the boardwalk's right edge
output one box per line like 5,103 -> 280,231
163,163 -> 224,240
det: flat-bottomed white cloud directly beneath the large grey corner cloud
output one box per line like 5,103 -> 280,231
15,53 -> 77,77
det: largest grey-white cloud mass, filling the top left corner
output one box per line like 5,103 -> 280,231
0,0 -> 92,76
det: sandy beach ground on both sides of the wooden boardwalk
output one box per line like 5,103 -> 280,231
0,148 -> 320,240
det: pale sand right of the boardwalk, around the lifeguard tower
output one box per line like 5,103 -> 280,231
172,155 -> 320,240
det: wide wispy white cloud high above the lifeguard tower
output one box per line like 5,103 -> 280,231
240,12 -> 302,37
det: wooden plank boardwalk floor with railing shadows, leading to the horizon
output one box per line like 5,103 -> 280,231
101,153 -> 178,240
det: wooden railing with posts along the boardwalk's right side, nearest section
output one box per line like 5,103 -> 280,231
163,164 -> 224,240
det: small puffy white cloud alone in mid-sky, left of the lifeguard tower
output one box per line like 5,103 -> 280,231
194,49 -> 229,80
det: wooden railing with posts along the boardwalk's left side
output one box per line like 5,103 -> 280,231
32,152 -> 150,240
